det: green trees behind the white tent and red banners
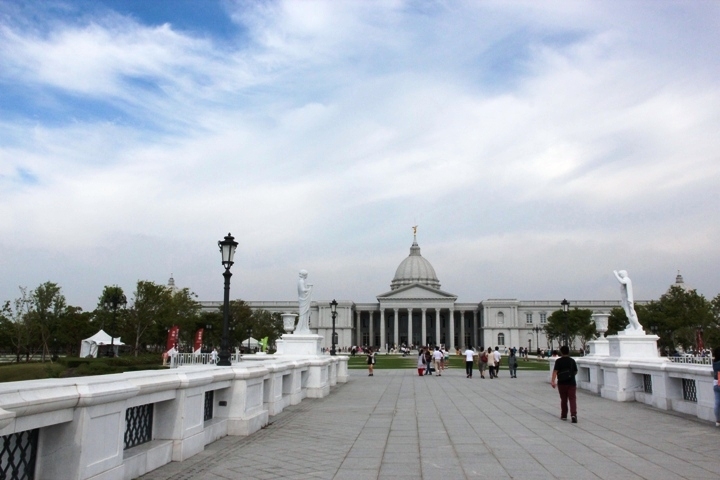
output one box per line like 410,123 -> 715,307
0,280 -> 284,362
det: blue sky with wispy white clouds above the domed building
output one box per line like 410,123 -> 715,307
0,0 -> 720,309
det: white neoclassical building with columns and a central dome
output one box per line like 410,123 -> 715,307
201,235 -> 640,351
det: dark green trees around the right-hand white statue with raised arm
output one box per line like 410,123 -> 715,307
543,286 -> 720,355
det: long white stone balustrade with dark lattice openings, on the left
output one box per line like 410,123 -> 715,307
0,355 -> 348,480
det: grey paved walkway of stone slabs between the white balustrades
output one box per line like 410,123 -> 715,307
141,369 -> 720,480
